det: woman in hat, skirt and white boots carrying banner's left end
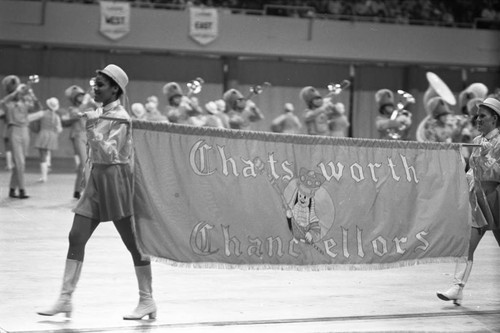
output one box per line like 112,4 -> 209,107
38,64 -> 156,320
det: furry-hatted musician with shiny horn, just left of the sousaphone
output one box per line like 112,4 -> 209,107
375,89 -> 412,140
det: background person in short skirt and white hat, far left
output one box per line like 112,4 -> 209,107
33,97 -> 63,183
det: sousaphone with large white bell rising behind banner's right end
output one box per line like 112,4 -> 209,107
416,72 -> 457,142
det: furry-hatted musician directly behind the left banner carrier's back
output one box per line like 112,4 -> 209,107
60,85 -> 97,199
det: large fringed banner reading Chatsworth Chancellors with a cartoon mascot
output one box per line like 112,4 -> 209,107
133,121 -> 470,269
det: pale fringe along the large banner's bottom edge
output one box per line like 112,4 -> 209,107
148,256 -> 467,272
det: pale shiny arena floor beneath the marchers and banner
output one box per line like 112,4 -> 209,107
0,161 -> 500,333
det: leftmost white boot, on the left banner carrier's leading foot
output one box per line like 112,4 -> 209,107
37,259 -> 83,318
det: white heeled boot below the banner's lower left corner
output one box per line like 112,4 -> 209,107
123,265 -> 156,320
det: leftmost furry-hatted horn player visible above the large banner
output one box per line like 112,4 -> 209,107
163,82 -> 202,125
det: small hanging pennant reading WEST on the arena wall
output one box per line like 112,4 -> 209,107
99,1 -> 130,40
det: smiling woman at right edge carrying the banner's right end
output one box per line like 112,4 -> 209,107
437,97 -> 500,305
